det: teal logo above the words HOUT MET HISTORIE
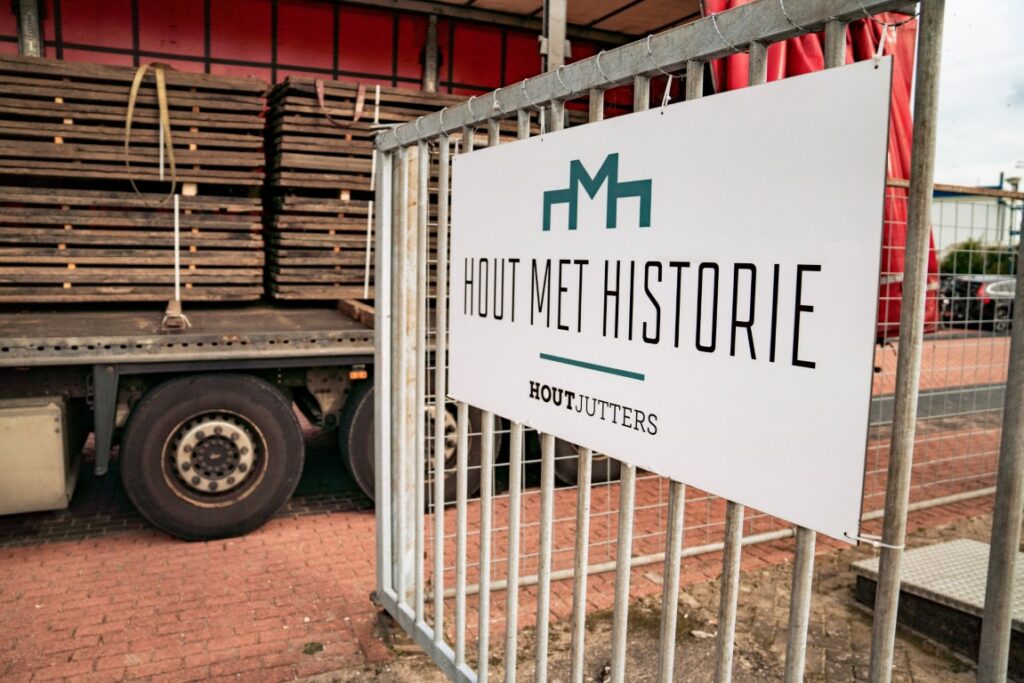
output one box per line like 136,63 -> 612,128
544,154 -> 650,230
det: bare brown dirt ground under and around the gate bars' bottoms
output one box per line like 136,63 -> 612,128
306,515 -> 1015,683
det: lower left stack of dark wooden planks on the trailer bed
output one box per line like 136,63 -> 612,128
0,187 -> 263,303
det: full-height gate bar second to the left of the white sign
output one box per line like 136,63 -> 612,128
414,140 -> 430,624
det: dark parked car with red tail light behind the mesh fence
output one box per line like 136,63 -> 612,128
941,275 -> 1017,332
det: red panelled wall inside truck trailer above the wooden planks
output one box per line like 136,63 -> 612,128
0,0 -> 618,94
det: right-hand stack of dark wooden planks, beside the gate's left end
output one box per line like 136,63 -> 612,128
265,77 -> 471,299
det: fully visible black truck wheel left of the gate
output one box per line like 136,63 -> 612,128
121,375 -> 304,541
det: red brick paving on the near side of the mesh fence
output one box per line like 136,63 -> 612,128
0,471 -> 991,681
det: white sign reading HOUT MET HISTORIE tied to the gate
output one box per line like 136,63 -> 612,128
449,59 -> 891,541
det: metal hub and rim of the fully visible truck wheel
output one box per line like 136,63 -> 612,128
174,416 -> 255,494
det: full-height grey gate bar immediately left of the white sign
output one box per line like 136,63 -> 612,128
432,134 -> 451,644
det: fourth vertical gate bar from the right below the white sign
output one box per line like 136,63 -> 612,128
610,76 -> 650,683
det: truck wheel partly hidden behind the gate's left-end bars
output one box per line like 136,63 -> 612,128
338,382 -> 491,503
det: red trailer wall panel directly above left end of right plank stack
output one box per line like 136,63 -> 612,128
276,0 -> 334,71
